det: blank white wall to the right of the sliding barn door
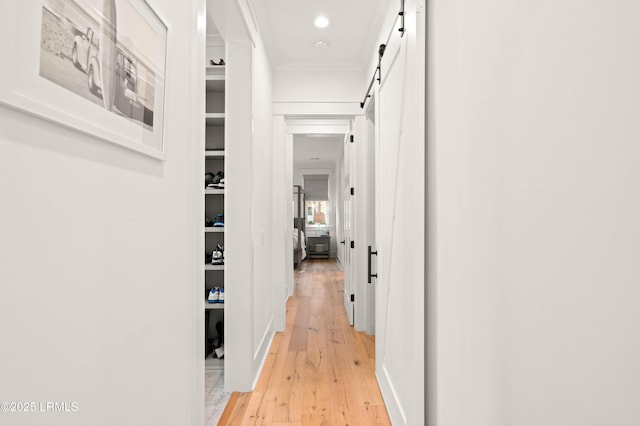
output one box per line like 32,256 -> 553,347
429,0 -> 640,426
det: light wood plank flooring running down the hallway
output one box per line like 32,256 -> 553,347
218,259 -> 391,426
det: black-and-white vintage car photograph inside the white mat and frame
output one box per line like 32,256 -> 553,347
40,0 -> 158,130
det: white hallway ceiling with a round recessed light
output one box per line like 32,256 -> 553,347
207,0 -> 391,70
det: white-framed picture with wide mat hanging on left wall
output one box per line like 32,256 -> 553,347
0,0 -> 167,160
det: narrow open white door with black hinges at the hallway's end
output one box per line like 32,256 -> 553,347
342,131 -> 355,325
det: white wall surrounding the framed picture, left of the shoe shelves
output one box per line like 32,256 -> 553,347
0,0 -> 204,426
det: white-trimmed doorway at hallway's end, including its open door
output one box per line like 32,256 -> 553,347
283,115 -> 376,335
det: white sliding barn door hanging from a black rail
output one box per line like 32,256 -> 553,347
375,2 -> 425,425
